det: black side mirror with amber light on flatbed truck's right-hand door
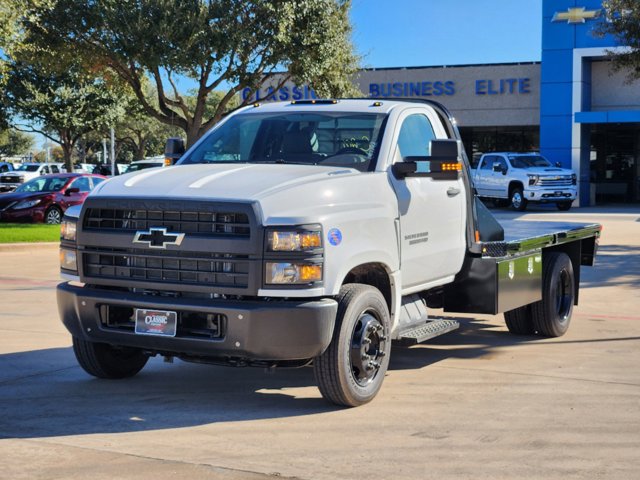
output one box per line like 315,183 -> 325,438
391,140 -> 462,180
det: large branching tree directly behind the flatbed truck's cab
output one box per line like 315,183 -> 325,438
21,0 -> 358,146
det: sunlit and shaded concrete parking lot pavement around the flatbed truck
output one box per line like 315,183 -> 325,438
0,209 -> 640,480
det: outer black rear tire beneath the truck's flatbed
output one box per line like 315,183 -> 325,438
531,252 -> 575,337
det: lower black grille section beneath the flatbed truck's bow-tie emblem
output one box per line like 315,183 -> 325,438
82,248 -> 250,288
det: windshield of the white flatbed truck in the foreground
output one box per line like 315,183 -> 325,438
178,113 -> 385,172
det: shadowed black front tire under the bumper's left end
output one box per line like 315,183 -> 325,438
73,337 -> 149,378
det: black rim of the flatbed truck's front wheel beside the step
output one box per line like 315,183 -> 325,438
350,312 -> 387,387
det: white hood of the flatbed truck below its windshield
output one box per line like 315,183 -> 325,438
91,163 -> 361,201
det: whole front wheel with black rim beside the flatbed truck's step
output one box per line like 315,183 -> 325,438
313,283 -> 391,407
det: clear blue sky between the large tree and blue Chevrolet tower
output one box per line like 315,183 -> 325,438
351,0 -> 542,68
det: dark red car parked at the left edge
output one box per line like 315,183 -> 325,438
0,173 -> 107,224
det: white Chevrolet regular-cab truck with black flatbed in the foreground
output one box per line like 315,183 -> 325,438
57,99 -> 600,406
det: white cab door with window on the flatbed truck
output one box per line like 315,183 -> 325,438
390,110 -> 466,293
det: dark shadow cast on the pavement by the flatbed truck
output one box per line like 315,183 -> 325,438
0,319 -> 536,438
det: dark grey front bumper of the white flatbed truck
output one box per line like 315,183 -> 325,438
57,283 -> 338,362
